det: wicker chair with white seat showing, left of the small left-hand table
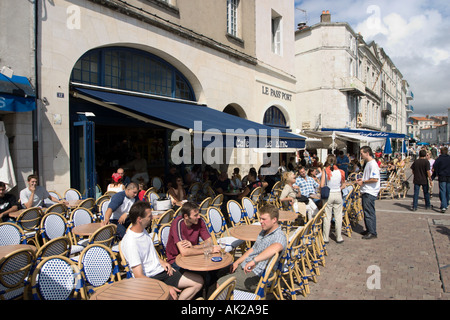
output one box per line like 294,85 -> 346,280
39,212 -> 84,255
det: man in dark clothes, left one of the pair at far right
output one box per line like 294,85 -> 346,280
411,150 -> 431,211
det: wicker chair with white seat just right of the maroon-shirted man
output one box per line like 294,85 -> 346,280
206,207 -> 245,253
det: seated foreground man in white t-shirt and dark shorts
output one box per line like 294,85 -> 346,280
121,201 -> 203,300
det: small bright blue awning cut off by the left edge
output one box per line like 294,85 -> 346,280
0,74 -> 36,112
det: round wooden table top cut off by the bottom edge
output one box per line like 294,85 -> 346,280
89,278 -> 169,300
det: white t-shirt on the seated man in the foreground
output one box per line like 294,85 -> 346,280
121,229 -> 164,277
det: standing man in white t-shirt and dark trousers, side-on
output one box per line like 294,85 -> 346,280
356,146 -> 380,240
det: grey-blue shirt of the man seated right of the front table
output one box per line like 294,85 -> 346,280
241,226 -> 287,276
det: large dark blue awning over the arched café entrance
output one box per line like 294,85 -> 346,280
76,88 -> 306,150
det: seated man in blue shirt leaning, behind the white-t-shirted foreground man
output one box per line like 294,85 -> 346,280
102,182 -> 139,239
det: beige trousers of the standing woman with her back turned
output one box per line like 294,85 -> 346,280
323,191 -> 343,242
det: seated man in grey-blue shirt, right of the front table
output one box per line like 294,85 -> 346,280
218,204 -> 287,292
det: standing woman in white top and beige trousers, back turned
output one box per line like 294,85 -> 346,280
320,155 -> 345,243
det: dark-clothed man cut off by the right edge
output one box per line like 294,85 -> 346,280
431,147 -> 450,213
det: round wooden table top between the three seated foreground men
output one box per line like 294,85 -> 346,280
175,252 -> 233,271
